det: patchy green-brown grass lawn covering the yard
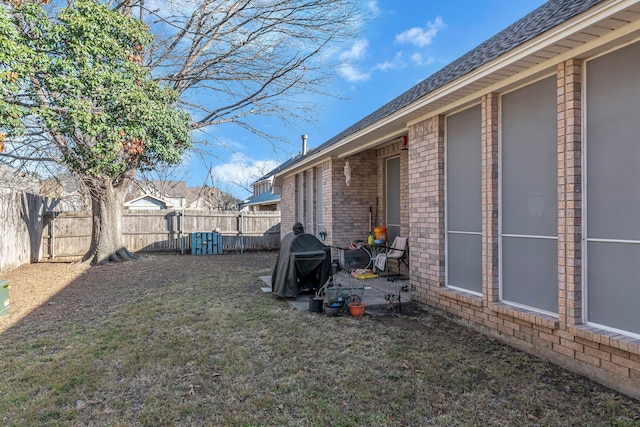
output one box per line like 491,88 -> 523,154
0,252 -> 640,426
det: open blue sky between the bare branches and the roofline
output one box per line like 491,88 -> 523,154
192,0 -> 545,198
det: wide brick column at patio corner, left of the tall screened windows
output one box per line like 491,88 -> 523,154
408,116 -> 445,303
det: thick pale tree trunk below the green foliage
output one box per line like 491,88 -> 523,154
82,172 -> 138,265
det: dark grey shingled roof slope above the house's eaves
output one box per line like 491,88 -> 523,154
298,0 -> 605,160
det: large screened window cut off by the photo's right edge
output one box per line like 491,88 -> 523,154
585,43 -> 640,337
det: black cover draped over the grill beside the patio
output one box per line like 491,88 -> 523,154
271,233 -> 331,298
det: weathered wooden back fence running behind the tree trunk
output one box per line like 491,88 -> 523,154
42,210 -> 280,258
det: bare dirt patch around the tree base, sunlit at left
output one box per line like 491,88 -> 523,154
0,252 -> 262,333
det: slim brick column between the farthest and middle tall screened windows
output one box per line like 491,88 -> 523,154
481,93 -> 500,304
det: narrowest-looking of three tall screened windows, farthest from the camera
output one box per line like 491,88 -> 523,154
446,106 -> 482,294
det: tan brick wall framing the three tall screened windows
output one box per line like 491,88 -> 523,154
408,59 -> 640,397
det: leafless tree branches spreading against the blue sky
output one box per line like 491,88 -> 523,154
111,0 -> 363,138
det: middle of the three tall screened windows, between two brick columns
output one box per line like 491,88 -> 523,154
500,76 -> 558,313
